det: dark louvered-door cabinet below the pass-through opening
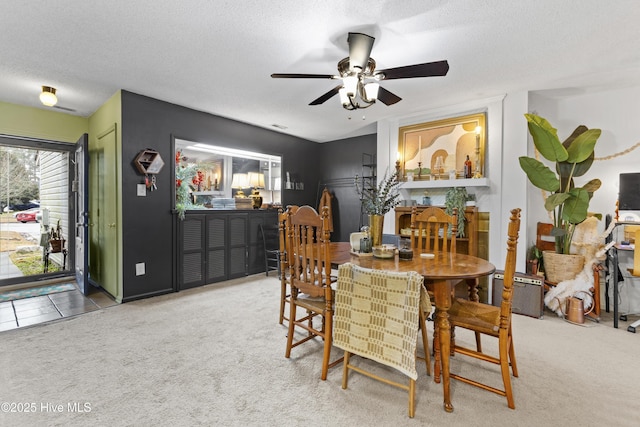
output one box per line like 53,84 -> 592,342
178,210 -> 278,290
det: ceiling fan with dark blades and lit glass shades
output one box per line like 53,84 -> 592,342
271,33 -> 449,110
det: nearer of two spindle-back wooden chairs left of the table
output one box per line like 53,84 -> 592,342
285,206 -> 339,380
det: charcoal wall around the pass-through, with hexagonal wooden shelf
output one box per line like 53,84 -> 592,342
122,90 -> 320,301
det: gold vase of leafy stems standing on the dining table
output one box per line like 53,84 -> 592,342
355,170 -> 401,246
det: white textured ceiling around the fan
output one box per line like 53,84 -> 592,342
0,0 -> 640,142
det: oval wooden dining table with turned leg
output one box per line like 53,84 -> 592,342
329,242 -> 496,412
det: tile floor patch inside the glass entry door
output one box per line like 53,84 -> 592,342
0,289 -> 116,331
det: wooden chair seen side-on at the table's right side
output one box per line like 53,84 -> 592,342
449,209 -> 520,409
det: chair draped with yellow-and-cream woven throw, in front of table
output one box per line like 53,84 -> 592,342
333,263 -> 430,418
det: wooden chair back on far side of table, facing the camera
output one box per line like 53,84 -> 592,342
411,206 -> 458,252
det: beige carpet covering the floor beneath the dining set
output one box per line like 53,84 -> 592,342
0,275 -> 640,427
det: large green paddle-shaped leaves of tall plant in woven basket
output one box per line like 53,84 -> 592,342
519,114 -> 601,280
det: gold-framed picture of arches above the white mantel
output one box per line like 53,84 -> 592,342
397,113 -> 487,181
